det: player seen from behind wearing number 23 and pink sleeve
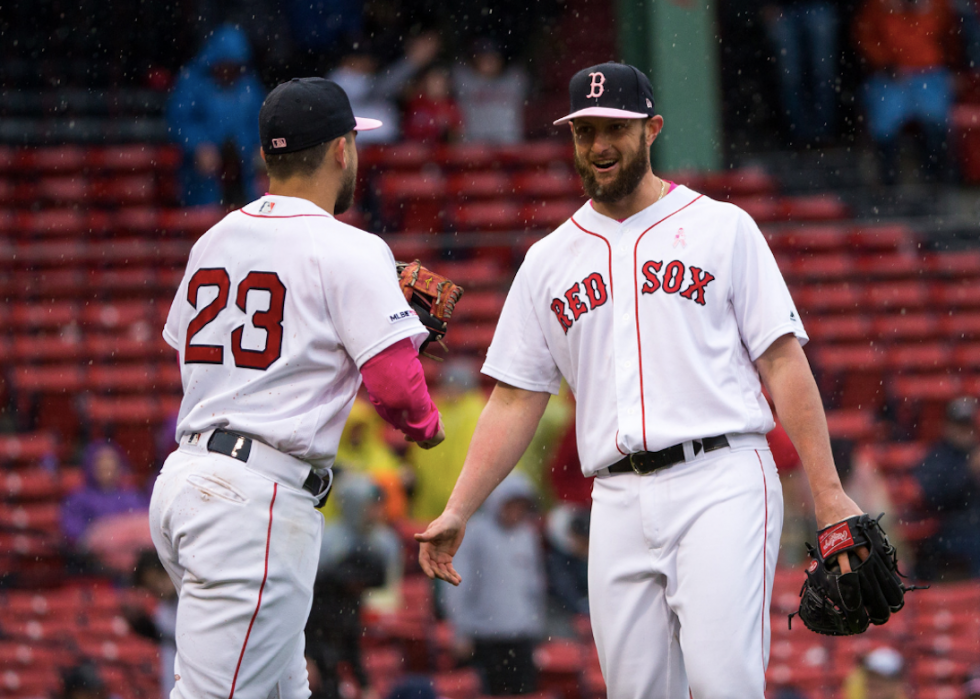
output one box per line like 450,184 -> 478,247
150,78 -> 444,699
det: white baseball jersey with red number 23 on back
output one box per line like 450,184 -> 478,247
163,195 -> 428,469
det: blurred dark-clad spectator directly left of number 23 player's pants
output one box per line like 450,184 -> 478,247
123,549 -> 177,699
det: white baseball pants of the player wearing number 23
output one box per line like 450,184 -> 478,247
150,433 -> 323,699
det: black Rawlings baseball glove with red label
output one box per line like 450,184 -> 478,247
789,514 -> 919,636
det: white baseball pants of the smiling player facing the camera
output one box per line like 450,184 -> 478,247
589,448 -> 783,699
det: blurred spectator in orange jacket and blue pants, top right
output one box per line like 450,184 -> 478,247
854,0 -> 954,184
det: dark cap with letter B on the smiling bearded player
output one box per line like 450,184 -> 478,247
555,63 -> 657,124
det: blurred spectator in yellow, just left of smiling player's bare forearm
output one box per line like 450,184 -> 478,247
408,359 -> 487,521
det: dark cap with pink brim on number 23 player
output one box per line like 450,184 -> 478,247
259,78 -> 381,155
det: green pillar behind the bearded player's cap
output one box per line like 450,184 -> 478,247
616,0 -> 722,171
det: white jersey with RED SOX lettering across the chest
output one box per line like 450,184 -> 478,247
483,186 -> 807,476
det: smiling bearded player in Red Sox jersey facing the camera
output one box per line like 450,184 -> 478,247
417,63 -> 861,699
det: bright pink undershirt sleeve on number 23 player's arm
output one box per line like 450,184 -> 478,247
361,339 -> 439,442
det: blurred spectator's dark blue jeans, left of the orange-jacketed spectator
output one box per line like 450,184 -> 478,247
762,0 -> 838,145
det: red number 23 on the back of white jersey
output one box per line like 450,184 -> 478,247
184,267 -> 286,371
